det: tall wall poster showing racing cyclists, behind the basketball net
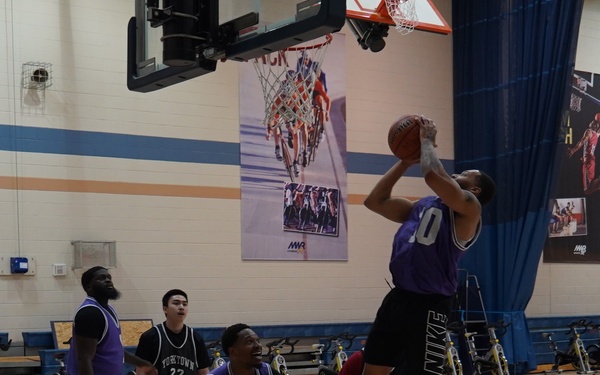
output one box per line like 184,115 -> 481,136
240,33 -> 348,261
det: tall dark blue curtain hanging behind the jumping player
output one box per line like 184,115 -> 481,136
452,0 -> 583,369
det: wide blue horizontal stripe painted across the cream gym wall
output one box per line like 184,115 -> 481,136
0,125 -> 454,177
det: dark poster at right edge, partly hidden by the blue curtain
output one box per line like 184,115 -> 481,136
544,71 -> 600,263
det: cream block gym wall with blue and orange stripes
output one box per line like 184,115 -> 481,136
0,0 -> 600,341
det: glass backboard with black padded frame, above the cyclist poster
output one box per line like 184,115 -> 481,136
127,0 -> 346,92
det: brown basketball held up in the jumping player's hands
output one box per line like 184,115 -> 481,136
388,115 -> 421,160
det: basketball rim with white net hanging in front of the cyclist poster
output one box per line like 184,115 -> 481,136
253,34 -> 333,126
